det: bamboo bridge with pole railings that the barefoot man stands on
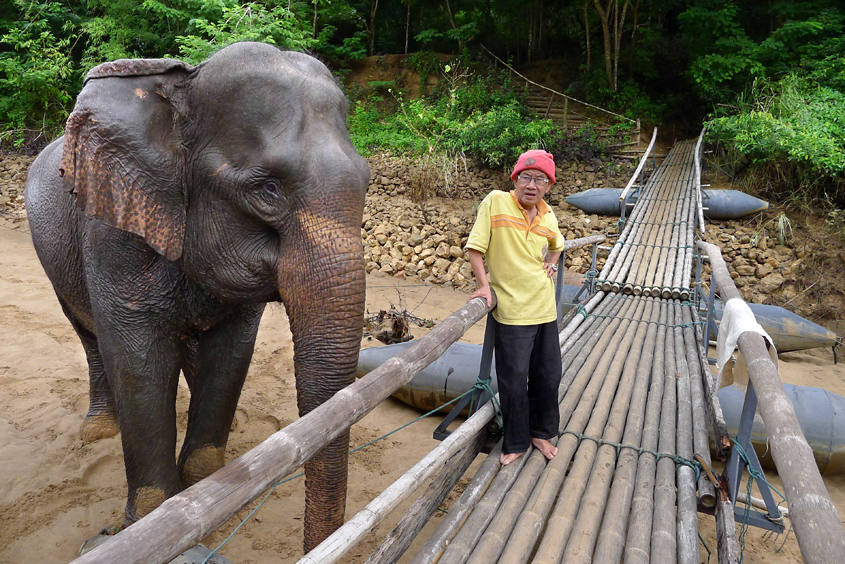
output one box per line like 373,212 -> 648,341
75,137 -> 845,564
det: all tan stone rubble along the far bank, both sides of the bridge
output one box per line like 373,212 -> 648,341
0,154 -> 804,314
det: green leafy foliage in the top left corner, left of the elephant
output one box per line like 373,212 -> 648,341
0,0 -> 78,147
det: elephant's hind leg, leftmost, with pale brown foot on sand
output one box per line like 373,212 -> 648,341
59,298 -> 120,444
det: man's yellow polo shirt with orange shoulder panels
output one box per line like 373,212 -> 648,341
466,190 -> 563,325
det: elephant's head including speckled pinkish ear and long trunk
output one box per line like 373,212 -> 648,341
54,43 -> 369,549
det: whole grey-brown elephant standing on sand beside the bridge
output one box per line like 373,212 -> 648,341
25,42 -> 370,551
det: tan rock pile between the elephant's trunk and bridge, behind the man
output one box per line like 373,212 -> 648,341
361,155 -> 625,287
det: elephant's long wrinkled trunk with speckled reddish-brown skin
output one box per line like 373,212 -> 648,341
279,218 -> 366,552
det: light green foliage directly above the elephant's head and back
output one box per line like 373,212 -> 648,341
175,0 -> 317,64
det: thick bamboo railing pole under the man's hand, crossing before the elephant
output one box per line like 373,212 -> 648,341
73,298 -> 495,564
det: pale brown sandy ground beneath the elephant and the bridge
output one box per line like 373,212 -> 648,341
0,214 -> 845,564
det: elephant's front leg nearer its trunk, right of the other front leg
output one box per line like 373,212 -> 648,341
177,304 -> 264,488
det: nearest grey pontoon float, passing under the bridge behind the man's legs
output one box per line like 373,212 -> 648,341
357,342 -> 845,475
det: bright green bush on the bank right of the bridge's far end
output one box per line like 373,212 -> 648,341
707,76 -> 845,201
